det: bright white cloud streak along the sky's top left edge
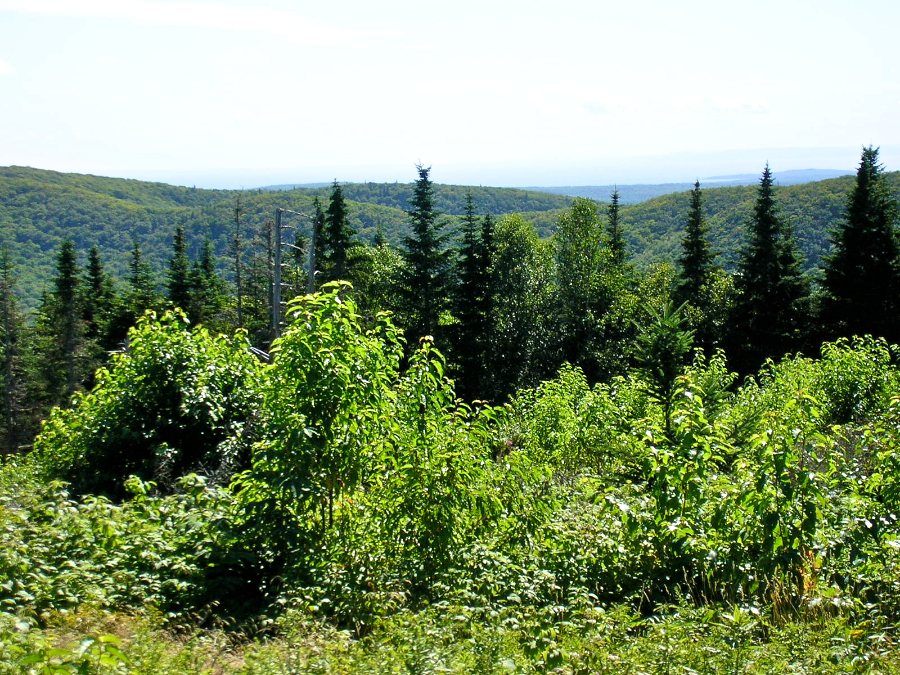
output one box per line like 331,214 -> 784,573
0,0 -> 391,47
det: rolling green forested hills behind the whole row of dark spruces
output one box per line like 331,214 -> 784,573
0,167 -> 900,309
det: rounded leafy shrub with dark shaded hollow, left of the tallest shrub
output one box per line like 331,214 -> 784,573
34,312 -> 261,497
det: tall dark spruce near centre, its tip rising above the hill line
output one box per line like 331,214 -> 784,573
400,164 -> 451,346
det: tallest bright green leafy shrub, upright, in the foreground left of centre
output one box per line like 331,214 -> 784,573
235,282 -> 402,564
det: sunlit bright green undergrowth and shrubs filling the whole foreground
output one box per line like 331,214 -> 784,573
0,287 -> 900,674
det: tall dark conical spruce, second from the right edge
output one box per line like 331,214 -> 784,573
732,164 -> 807,373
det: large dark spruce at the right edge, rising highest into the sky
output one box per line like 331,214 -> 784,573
820,146 -> 900,342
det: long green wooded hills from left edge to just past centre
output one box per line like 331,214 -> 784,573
0,167 -> 572,309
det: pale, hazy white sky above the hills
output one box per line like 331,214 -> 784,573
0,0 -> 900,188
